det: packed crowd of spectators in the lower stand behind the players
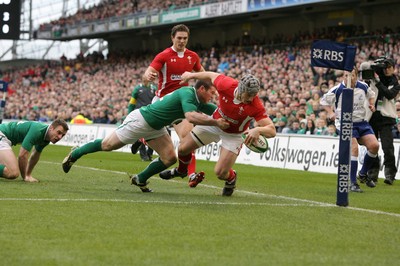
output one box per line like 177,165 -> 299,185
1,27 -> 400,135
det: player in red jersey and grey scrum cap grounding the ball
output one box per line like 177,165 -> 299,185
160,72 -> 276,196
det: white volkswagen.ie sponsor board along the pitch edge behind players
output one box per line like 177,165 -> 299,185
57,124 -> 400,177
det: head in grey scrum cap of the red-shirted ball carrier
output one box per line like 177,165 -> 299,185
235,74 -> 260,104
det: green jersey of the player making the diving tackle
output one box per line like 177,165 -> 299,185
140,87 -> 217,129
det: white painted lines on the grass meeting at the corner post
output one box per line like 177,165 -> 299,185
35,161 -> 400,217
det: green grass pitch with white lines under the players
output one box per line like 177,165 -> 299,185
0,145 -> 400,266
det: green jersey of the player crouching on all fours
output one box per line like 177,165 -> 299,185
0,121 -> 50,152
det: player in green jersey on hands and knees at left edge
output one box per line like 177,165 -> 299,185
0,119 -> 68,182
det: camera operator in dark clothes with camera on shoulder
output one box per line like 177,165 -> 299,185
360,58 -> 400,185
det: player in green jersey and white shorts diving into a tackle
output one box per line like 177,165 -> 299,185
62,81 -> 229,192
